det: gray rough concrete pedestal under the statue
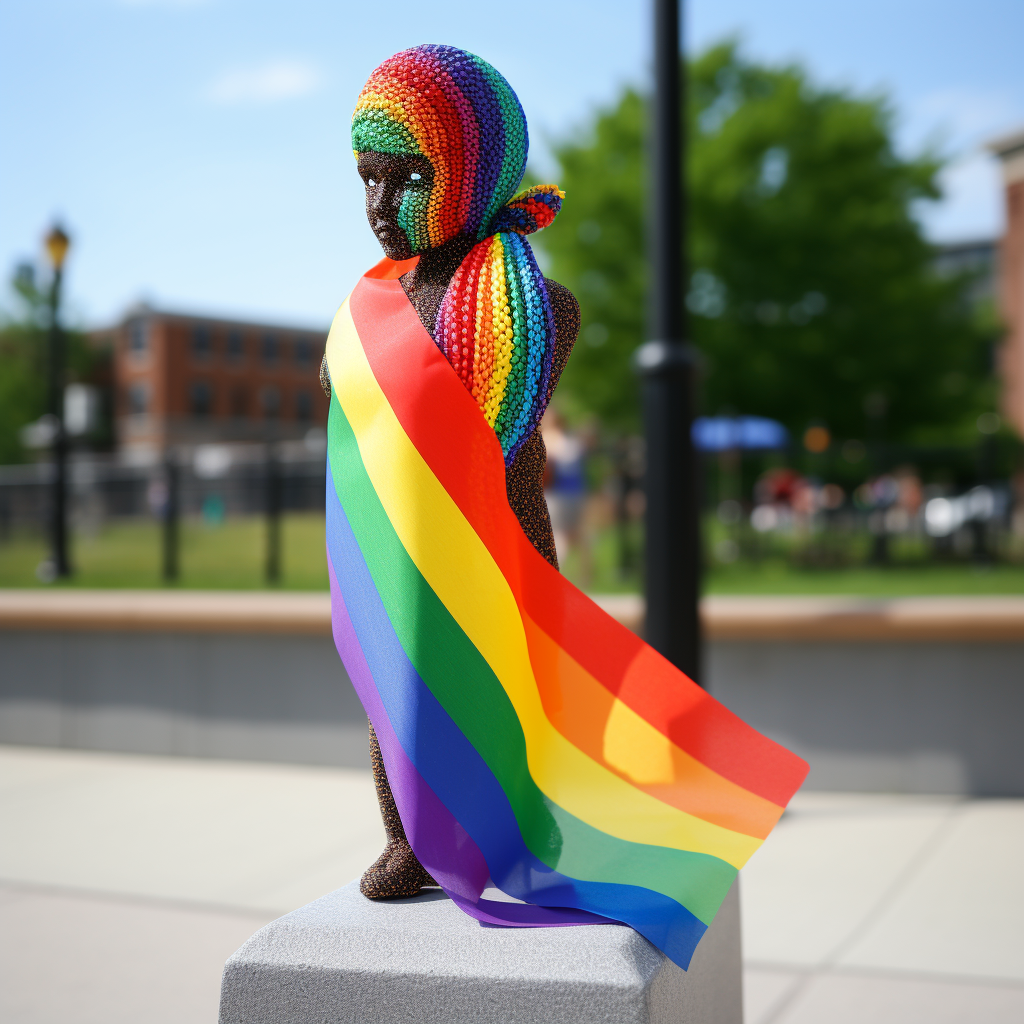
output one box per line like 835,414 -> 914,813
220,882 -> 743,1024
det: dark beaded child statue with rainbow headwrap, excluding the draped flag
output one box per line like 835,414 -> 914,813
321,46 -> 580,899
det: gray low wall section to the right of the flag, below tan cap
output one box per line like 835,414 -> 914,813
708,640 -> 1024,797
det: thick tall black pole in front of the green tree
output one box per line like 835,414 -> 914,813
637,0 -> 700,682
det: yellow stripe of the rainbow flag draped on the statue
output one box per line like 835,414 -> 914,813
327,300 -> 761,868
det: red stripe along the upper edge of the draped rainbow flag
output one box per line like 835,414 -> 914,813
349,260 -> 808,807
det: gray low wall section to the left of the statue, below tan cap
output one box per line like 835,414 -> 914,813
0,630 -> 370,768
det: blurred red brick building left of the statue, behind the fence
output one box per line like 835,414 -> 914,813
93,305 -> 328,463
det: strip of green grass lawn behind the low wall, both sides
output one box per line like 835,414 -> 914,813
0,513 -> 1024,597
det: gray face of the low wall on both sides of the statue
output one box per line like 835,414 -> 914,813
0,629 -> 1024,796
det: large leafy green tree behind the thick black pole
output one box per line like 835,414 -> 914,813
539,43 -> 993,439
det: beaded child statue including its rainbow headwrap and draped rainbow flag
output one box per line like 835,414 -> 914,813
321,46 -> 807,968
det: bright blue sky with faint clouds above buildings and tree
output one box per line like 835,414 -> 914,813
0,0 -> 1024,326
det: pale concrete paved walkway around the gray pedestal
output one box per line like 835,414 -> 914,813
0,746 -> 1024,1024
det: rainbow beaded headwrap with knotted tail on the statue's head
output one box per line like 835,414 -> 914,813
352,45 -> 562,464
